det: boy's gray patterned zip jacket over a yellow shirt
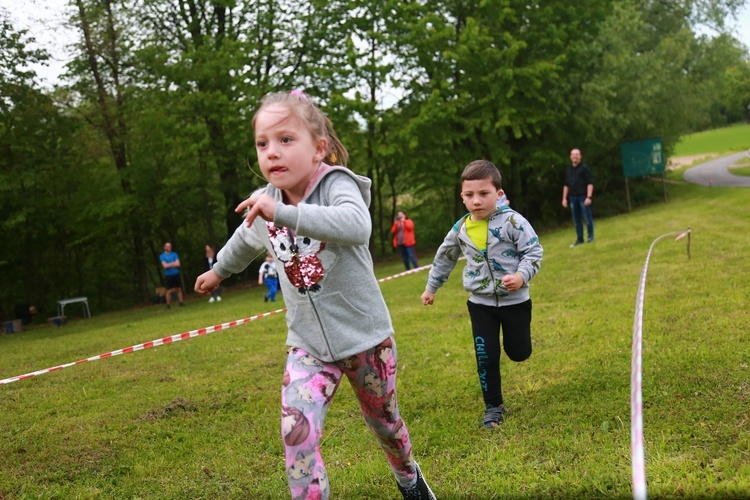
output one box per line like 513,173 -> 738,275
427,205 -> 543,306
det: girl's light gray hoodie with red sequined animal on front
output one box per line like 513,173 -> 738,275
213,164 -> 393,362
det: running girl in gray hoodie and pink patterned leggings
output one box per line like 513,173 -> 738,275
195,91 -> 435,499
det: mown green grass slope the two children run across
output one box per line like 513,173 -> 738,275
0,185 -> 750,499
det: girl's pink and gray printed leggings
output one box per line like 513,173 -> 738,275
281,337 -> 416,500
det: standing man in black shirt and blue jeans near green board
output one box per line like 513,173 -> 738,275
562,149 -> 594,248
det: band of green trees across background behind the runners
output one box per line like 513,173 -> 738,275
0,0 -> 750,315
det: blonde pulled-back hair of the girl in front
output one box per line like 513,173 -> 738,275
253,90 -> 349,166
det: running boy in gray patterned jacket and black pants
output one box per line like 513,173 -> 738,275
422,160 -> 542,429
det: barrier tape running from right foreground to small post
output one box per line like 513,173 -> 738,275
630,228 -> 690,500
